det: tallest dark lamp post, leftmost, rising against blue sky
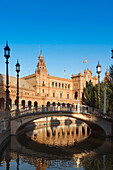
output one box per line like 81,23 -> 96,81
4,42 -> 10,111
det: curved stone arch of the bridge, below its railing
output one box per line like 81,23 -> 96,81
11,112 -> 106,136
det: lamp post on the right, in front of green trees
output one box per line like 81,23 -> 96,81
96,61 -> 101,109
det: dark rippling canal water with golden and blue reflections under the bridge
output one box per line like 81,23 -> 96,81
0,118 -> 113,170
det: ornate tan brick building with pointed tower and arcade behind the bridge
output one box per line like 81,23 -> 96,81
0,50 -> 97,110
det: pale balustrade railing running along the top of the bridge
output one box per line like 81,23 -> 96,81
0,104 -> 103,120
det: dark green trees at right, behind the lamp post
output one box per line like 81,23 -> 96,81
82,76 -> 113,114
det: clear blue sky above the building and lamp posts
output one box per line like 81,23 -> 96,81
0,0 -> 113,81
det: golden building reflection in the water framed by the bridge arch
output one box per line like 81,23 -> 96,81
26,123 -> 91,147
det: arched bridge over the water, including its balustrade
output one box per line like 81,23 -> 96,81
10,105 -> 113,136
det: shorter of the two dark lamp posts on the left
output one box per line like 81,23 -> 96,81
16,60 -> 20,112
